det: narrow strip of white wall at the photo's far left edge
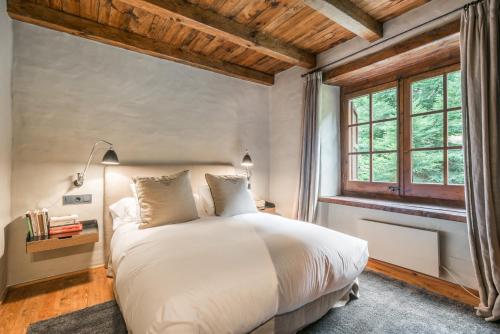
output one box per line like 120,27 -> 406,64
0,0 -> 13,294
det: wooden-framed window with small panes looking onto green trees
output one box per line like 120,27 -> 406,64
342,65 -> 464,204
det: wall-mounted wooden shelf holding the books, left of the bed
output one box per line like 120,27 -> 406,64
26,220 -> 99,253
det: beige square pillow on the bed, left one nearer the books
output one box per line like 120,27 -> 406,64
134,170 -> 198,228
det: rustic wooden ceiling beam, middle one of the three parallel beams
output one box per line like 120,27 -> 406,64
117,0 -> 316,68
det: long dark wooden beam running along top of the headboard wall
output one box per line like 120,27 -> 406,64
7,0 -> 274,85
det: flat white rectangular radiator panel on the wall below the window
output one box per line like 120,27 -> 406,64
357,220 -> 439,277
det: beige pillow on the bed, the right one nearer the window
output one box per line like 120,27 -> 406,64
205,174 -> 257,217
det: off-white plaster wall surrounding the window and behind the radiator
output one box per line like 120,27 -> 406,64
269,0 -> 477,287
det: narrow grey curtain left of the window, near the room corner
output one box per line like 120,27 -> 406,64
297,72 -> 322,223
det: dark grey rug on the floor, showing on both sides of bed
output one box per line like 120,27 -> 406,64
28,272 -> 500,334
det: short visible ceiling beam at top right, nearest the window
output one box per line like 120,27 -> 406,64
305,0 -> 382,42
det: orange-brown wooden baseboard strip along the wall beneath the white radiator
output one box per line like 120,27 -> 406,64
366,259 -> 479,306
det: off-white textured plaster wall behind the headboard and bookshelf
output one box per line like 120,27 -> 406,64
8,22 -> 270,284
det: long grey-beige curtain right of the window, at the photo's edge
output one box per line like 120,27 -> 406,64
460,0 -> 500,321
